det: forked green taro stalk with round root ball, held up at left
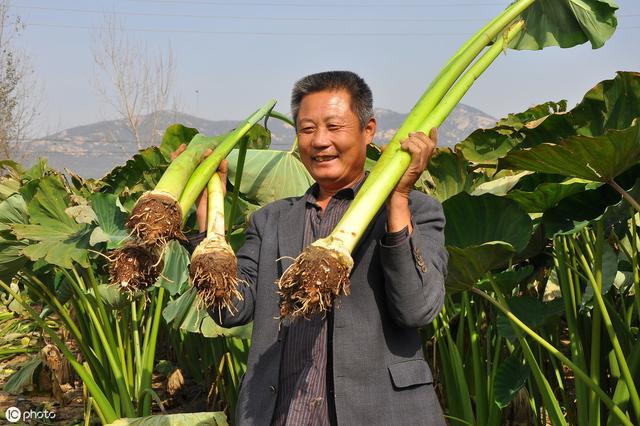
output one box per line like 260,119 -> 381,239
127,100 -> 275,246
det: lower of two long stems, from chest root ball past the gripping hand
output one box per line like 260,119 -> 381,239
328,21 -> 523,253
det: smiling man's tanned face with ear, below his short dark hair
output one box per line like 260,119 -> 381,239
297,90 -> 376,190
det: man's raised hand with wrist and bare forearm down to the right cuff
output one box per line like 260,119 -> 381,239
387,127 -> 438,233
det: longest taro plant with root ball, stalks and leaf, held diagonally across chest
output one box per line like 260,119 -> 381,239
278,0 -> 617,316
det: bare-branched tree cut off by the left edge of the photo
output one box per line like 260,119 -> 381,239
0,0 -> 38,160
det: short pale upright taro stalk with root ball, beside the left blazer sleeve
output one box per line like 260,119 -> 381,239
189,173 -> 242,312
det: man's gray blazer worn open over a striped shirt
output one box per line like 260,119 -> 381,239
212,191 -> 448,426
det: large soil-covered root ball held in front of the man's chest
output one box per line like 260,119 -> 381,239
278,245 -> 350,318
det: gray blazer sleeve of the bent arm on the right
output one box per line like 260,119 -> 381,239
379,191 -> 448,327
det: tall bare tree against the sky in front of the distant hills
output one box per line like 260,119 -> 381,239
91,15 -> 175,149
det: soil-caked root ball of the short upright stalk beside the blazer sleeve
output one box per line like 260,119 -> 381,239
189,248 -> 242,313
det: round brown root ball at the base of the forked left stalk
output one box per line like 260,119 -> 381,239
127,194 -> 186,246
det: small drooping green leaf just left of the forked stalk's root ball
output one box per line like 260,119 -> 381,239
90,193 -> 129,250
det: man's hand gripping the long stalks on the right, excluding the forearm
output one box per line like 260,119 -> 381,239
392,127 -> 438,198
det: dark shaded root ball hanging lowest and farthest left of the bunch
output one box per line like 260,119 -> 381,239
109,244 -> 162,293
